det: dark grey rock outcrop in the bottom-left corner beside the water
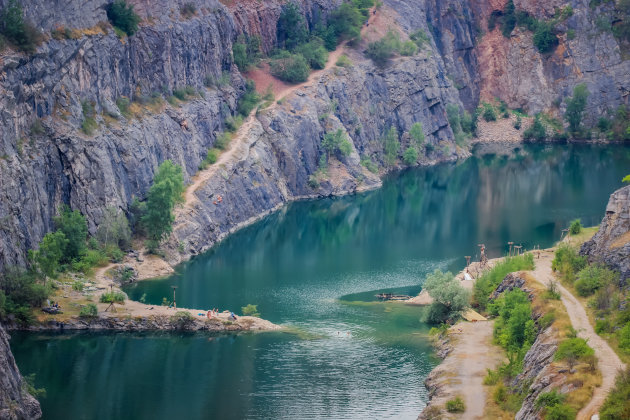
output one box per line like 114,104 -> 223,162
0,325 -> 42,420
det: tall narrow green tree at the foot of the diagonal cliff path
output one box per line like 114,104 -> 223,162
142,160 -> 184,252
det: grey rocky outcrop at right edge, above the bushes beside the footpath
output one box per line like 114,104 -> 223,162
580,186 -> 630,282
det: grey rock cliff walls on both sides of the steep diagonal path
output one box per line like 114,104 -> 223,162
0,0 -> 466,267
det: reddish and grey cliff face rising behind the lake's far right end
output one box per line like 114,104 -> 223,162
471,0 -> 630,123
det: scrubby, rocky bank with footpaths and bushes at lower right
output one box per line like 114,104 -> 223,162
418,221 -> 630,420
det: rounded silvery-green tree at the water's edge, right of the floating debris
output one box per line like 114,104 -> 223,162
423,270 -> 470,323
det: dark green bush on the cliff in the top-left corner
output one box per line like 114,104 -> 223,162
0,0 -> 43,53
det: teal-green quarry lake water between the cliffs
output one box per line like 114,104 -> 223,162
11,145 -> 630,419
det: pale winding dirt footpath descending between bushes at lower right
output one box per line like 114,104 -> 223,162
533,251 -> 625,420
